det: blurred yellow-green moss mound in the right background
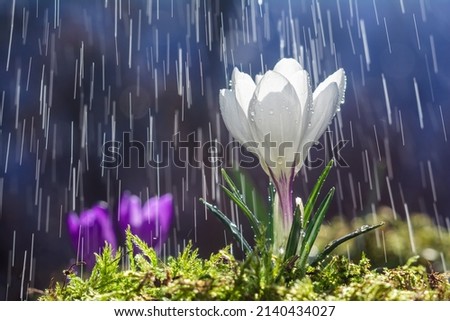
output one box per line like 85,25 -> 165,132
315,207 -> 450,271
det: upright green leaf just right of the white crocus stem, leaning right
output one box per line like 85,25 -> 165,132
298,187 -> 335,275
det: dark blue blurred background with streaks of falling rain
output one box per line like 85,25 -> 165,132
0,0 -> 450,300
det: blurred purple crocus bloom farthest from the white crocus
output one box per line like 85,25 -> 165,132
67,203 -> 117,269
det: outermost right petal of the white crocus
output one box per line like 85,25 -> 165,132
302,82 -> 339,144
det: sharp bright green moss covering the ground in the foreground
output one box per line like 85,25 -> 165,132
40,212 -> 450,300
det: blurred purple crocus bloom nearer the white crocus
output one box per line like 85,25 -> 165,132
119,192 -> 173,251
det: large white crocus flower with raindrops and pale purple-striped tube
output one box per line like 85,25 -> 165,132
219,59 -> 346,246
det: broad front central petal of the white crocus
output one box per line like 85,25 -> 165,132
249,71 -> 301,175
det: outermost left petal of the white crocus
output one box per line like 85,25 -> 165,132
219,89 -> 252,144
